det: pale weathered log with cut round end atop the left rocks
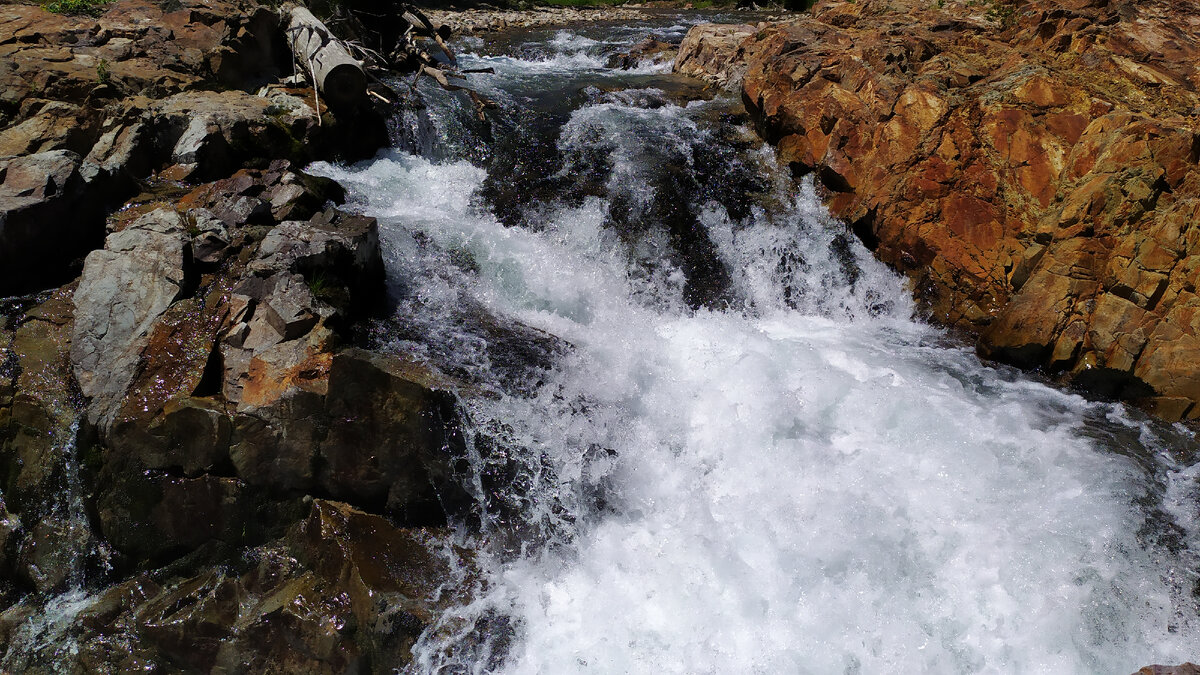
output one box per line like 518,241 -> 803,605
287,6 -> 367,108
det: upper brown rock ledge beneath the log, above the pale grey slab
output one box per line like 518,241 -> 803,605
0,0 -> 386,297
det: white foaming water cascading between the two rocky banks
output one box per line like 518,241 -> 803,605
316,14 -> 1200,674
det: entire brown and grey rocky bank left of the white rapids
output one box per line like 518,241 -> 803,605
0,0 -> 487,673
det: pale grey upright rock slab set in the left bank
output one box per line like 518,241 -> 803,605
71,208 -> 190,425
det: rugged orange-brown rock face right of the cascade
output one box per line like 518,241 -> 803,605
676,0 -> 1200,419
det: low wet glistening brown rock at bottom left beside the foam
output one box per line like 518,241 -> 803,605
12,500 -> 473,674
